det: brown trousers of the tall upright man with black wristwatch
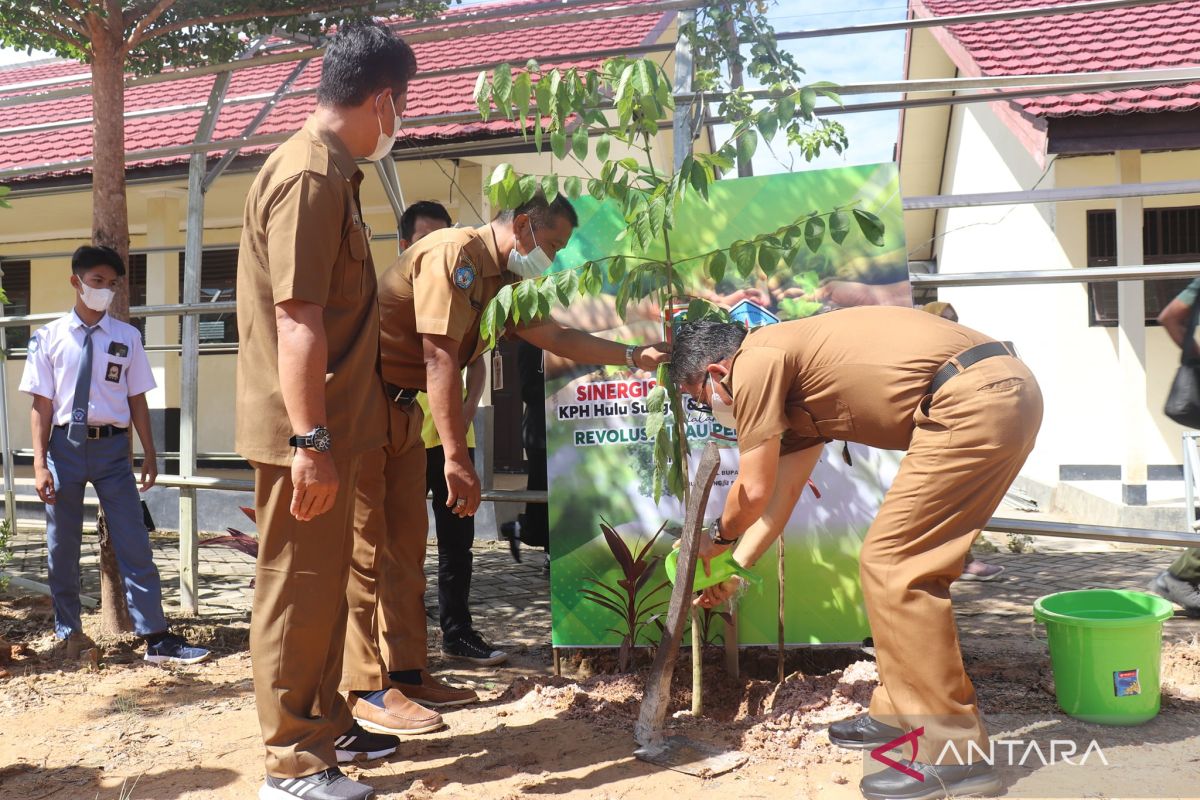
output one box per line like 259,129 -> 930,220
250,456 -> 359,777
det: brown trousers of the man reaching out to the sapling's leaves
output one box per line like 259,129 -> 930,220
342,403 -> 428,692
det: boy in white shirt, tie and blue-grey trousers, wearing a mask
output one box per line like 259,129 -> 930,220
20,246 -> 209,663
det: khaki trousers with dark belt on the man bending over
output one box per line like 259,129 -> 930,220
860,356 -> 1042,763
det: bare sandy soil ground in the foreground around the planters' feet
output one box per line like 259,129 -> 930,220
0,597 -> 1200,800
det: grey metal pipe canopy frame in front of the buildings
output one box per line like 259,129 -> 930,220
0,0 -> 1200,614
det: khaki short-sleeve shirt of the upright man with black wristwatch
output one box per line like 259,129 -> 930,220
235,118 -> 388,465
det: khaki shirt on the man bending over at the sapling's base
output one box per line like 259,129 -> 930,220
727,306 -> 994,453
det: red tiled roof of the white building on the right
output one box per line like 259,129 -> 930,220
912,0 -> 1200,118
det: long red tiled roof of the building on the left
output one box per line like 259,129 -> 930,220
0,0 -> 667,184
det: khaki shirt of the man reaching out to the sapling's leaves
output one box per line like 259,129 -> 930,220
379,225 -> 517,390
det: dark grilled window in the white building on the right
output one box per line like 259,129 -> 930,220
1087,206 -> 1200,325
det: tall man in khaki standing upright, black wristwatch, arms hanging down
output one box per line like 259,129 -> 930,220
236,24 -> 416,800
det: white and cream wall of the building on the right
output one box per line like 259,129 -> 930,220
931,104 -> 1200,483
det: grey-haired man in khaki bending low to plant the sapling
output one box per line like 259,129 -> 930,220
671,306 -> 1042,799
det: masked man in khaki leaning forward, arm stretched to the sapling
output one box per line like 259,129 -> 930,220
342,194 -> 667,733
